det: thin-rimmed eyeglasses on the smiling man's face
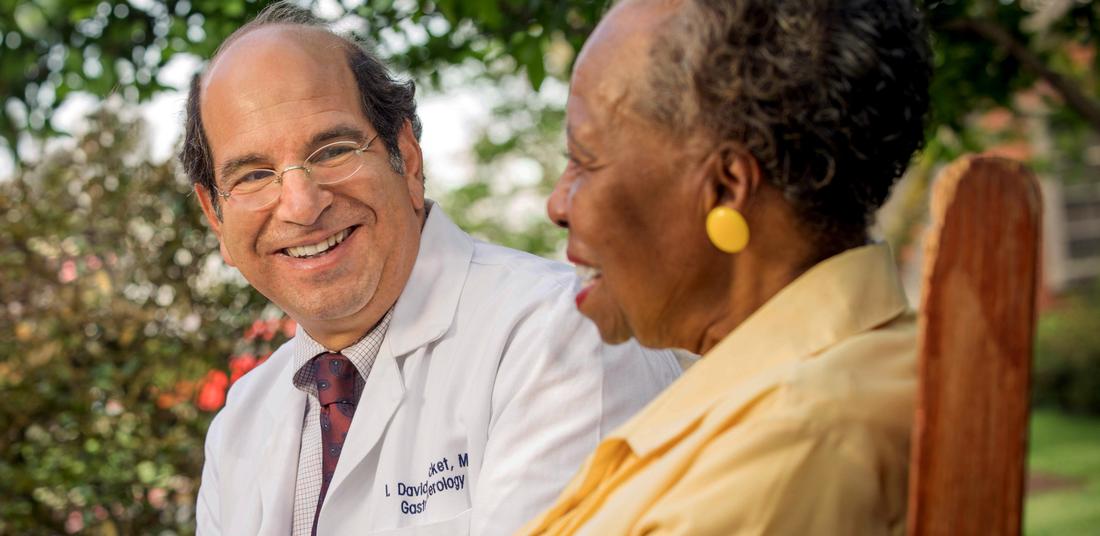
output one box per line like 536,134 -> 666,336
215,134 -> 378,210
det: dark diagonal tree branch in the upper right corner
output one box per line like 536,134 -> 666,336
944,19 -> 1100,132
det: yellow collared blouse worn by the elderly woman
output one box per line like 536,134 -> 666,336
520,244 -> 916,536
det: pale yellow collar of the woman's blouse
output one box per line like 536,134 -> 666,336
612,243 -> 909,456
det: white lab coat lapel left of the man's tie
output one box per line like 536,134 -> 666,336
255,360 -> 306,534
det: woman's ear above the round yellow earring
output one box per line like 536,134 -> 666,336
703,142 -> 762,214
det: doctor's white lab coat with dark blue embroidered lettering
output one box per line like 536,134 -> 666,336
197,206 -> 680,536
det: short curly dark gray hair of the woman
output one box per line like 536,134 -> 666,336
641,0 -> 931,251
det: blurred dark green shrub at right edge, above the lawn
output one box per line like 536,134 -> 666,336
1032,284 -> 1100,415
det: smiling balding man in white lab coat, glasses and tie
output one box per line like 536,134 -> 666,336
180,4 -> 679,535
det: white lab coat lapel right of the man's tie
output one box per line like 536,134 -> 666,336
321,205 -> 473,504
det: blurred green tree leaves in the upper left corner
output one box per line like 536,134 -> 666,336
0,0 -> 259,152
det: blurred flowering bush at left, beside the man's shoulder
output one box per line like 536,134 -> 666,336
0,107 -> 277,534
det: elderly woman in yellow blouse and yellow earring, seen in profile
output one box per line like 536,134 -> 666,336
525,0 -> 930,535
